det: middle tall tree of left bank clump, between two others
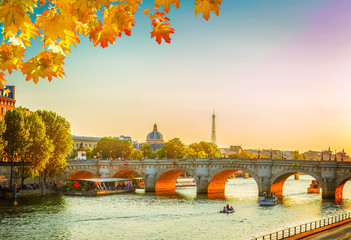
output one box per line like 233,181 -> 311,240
21,112 -> 53,187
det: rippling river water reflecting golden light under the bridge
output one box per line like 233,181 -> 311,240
0,175 -> 351,240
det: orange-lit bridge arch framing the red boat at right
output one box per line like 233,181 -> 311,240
270,169 -> 327,196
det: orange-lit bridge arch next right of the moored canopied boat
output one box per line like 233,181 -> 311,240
155,169 -> 196,194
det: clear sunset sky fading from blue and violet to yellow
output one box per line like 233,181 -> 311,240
7,0 -> 351,154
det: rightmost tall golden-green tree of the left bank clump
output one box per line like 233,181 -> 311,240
37,110 -> 73,182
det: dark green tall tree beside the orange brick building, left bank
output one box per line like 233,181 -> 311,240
3,107 -> 29,185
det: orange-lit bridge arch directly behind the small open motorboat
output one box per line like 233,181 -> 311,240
207,167 -> 262,196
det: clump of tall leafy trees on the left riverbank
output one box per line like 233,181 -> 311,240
0,107 -> 73,186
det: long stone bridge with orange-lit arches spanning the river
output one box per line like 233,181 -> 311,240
61,159 -> 351,199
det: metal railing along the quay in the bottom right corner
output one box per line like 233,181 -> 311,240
252,213 -> 351,240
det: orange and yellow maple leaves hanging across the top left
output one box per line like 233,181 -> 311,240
0,0 -> 222,88
